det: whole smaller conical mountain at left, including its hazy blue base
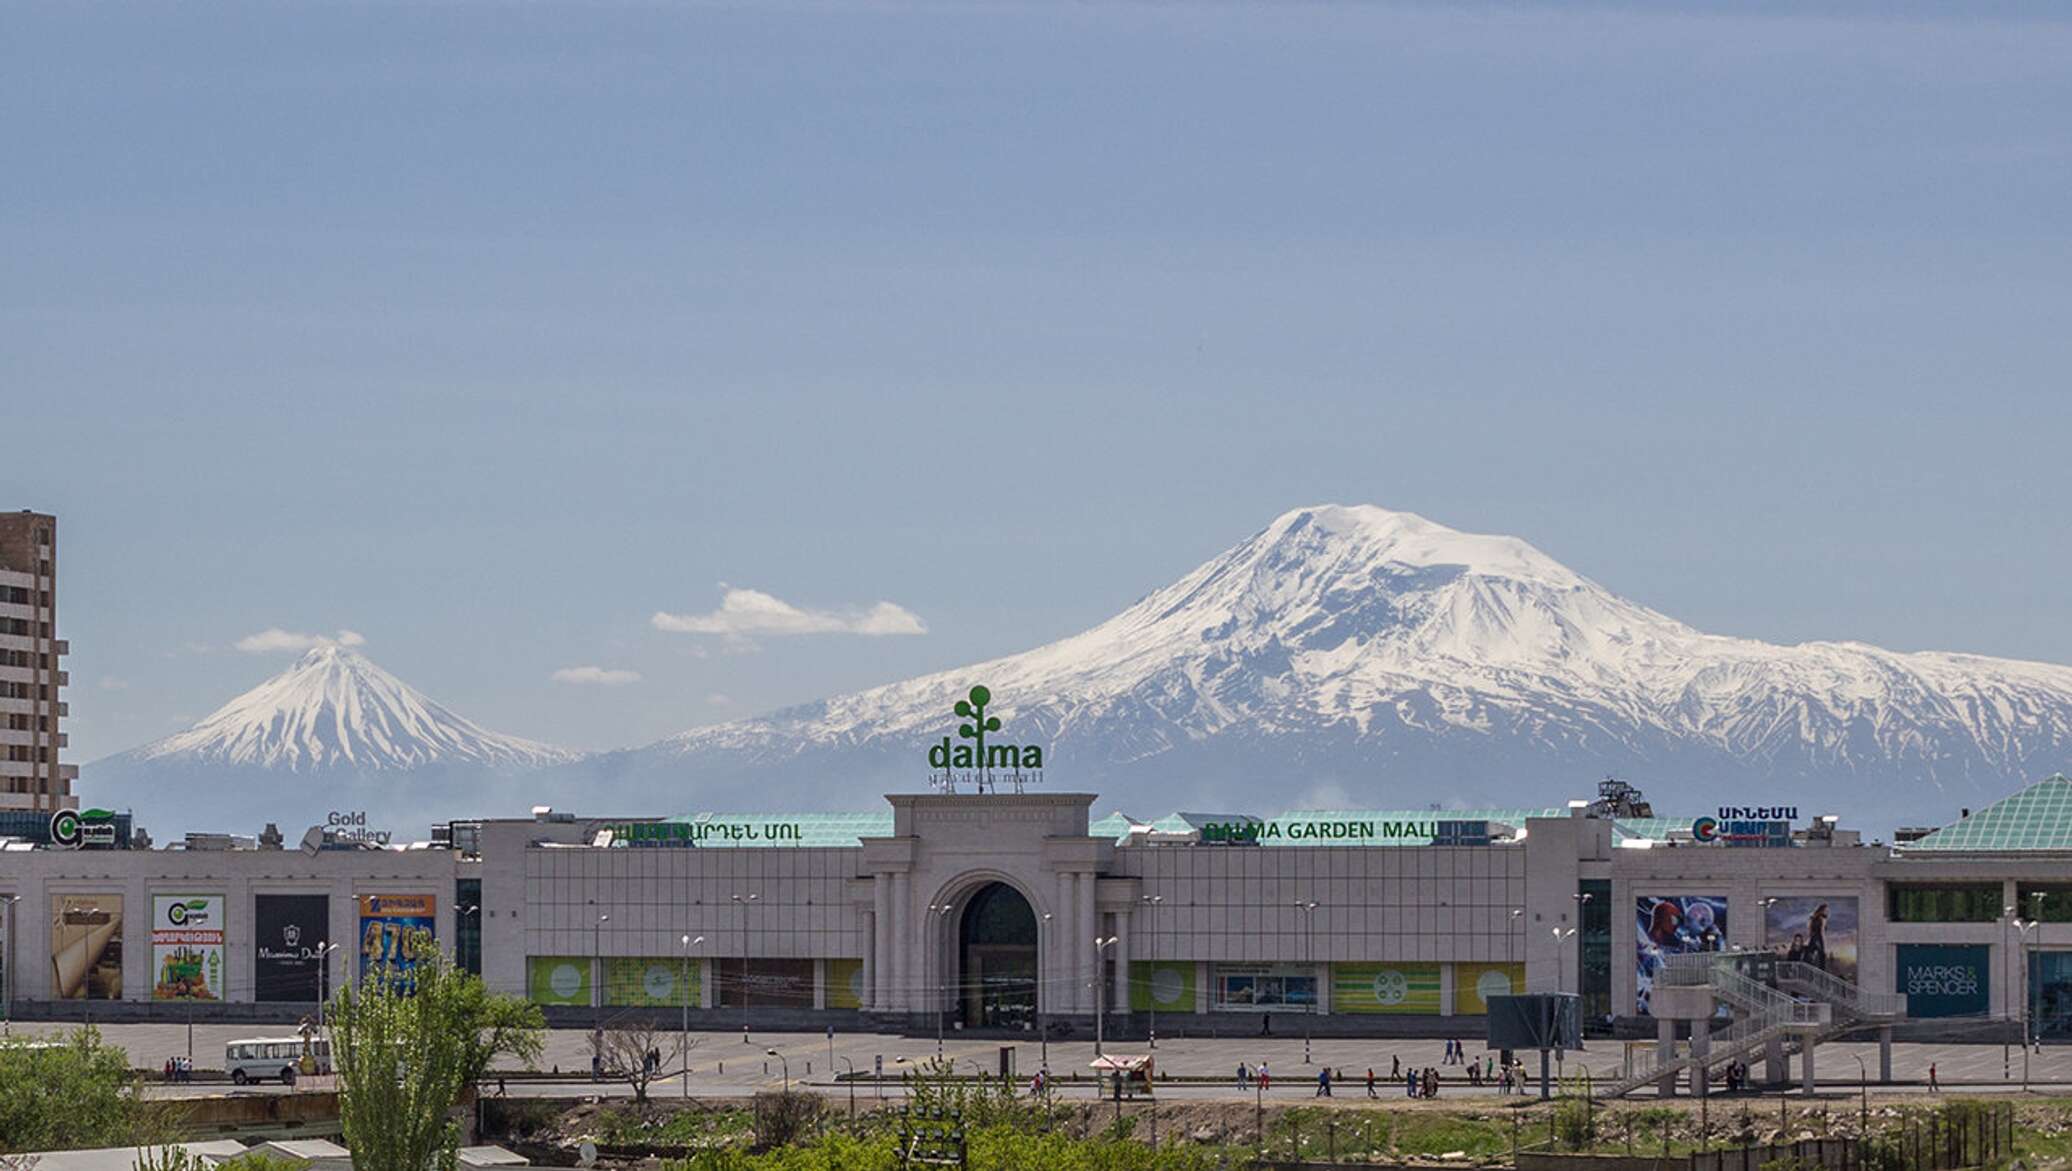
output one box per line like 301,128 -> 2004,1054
81,647 -> 578,837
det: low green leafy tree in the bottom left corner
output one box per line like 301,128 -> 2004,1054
0,1026 -> 164,1152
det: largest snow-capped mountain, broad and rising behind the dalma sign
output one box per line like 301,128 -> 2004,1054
601,506 -> 2072,821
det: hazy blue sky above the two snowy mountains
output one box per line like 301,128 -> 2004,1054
0,2 -> 2072,761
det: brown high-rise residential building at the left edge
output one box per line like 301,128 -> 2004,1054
0,510 -> 79,812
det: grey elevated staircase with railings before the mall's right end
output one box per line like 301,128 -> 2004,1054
1604,951 -> 1906,1098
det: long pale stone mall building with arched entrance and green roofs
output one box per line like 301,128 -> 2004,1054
0,777 -> 2072,1036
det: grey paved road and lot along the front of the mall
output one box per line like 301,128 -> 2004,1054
12,1024 -> 2072,1101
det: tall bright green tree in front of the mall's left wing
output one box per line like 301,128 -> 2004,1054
329,953 -> 545,1171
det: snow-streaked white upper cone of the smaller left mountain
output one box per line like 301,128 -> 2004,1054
133,645 -> 576,771
